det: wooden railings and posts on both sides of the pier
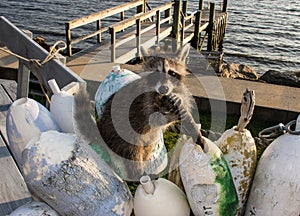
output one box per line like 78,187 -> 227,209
66,0 -> 228,59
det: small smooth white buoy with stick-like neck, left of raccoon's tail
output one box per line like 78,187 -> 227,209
48,79 -> 75,133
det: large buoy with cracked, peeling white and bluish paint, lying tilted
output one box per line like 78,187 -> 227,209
22,131 -> 133,215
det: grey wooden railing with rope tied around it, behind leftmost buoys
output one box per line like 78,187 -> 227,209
0,16 -> 85,98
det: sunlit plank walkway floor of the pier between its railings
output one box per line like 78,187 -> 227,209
67,22 -> 171,95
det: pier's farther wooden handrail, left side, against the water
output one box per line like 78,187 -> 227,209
65,0 -> 147,56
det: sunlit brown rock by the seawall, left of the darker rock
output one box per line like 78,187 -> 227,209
220,63 -> 259,80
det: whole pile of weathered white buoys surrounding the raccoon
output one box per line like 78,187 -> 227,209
7,68 -> 300,216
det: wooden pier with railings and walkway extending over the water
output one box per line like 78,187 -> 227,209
66,0 -> 227,78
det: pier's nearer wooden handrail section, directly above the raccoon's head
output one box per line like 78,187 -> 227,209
110,2 -> 174,62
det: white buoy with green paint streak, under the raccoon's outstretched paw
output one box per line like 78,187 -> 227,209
179,137 -> 238,216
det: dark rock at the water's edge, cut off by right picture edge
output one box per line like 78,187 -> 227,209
260,70 -> 300,88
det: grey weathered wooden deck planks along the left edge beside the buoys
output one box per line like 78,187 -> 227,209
0,80 -> 32,215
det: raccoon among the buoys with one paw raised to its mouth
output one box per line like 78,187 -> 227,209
75,45 -> 202,179
